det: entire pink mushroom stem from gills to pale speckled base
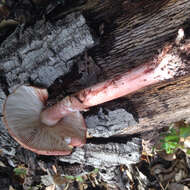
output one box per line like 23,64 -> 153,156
41,46 -> 182,125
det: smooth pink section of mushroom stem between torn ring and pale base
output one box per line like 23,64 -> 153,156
75,65 -> 159,108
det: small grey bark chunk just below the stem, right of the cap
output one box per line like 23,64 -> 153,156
85,108 -> 137,137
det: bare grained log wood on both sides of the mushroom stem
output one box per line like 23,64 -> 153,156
78,0 -> 190,134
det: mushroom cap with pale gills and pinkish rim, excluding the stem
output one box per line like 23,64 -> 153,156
3,86 -> 86,155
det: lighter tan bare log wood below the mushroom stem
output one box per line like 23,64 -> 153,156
93,75 -> 190,135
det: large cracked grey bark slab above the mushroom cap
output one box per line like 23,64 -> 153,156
0,13 -> 94,87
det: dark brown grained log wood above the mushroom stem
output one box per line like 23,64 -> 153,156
82,0 -> 190,77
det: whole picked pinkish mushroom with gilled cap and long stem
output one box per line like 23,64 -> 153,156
4,30 -> 184,155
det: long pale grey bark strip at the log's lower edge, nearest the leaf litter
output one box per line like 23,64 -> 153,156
59,138 -> 141,168
